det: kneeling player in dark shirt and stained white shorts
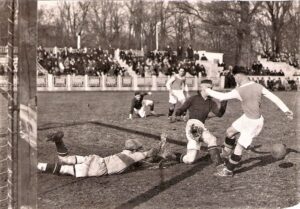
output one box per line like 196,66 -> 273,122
175,80 -> 227,166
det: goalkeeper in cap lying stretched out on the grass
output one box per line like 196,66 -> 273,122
37,131 -> 166,177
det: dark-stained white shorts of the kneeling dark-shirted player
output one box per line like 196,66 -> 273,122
185,119 -> 217,151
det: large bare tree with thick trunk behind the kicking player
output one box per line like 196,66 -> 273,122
178,1 -> 261,65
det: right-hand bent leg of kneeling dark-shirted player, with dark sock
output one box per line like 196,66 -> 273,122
202,130 -> 223,166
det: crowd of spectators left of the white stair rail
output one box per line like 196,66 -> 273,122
37,46 -> 126,76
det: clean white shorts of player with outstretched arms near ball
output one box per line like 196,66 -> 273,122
232,114 -> 264,148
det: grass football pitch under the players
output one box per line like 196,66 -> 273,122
38,92 -> 300,209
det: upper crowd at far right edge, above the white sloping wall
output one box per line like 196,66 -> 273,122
261,53 -> 300,69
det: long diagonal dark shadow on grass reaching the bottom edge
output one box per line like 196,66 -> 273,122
116,155 -> 210,209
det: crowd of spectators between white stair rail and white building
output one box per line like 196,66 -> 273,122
119,45 -> 207,77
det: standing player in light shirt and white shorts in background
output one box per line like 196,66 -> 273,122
166,68 -> 189,119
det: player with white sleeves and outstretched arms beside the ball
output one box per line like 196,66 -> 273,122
205,67 -> 293,176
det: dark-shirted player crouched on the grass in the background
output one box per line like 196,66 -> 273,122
128,92 -> 157,120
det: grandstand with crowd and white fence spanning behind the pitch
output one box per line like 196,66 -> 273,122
0,47 -> 299,91
